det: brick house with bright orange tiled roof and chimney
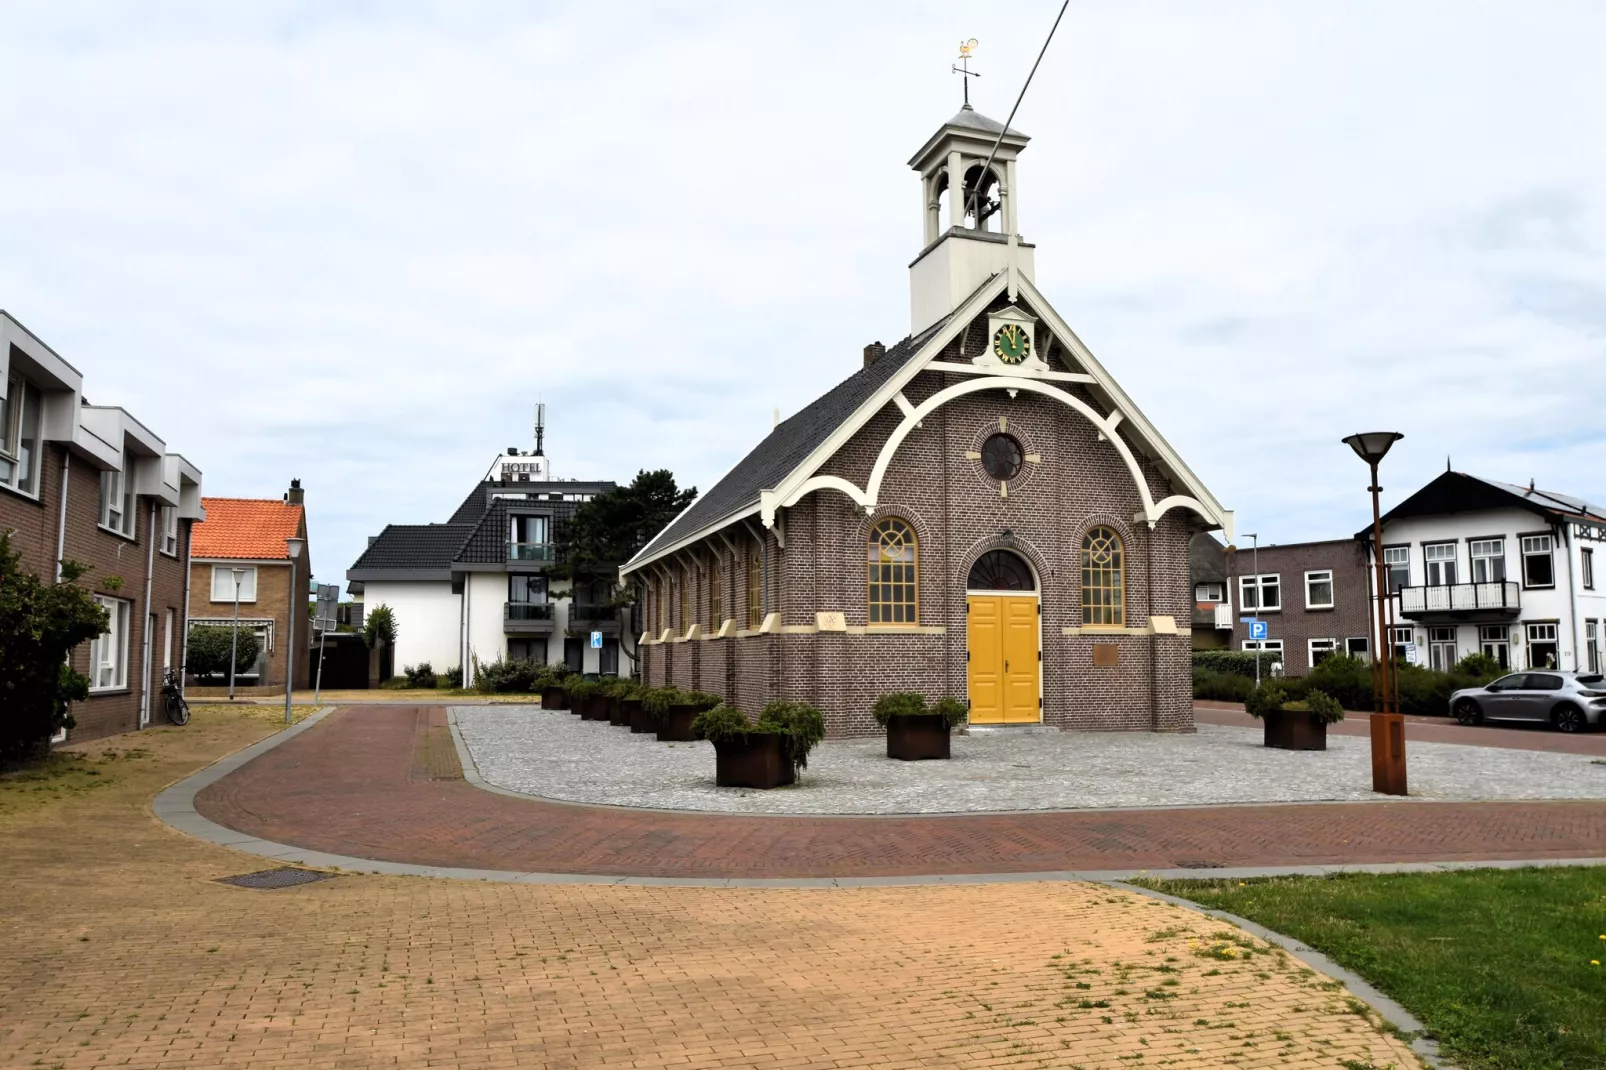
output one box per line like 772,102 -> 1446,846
190,479 -> 312,692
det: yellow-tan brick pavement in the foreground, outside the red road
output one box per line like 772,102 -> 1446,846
0,709 -> 1416,1070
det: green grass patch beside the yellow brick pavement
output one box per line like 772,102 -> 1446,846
1142,866 -> 1606,1070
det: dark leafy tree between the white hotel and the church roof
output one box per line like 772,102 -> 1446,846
551,468 -> 697,582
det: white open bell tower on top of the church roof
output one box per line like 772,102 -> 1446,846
909,103 -> 1033,334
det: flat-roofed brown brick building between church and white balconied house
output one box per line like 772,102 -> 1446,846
1225,538 -> 1376,676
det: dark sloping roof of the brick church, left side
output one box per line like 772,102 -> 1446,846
636,317 -> 951,559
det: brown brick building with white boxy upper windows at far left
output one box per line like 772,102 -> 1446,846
0,312 -> 206,742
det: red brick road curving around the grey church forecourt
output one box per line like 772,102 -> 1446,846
196,705 -> 1606,877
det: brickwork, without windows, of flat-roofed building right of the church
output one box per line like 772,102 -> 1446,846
1227,538 -> 1372,676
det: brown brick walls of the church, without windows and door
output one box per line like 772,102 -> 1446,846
641,320 -> 1200,736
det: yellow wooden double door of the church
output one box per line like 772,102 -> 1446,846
965,594 -> 1042,725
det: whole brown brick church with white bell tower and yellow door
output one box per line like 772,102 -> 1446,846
622,104 -> 1232,737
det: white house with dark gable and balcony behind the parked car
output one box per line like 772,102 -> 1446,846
1357,472 -> 1606,672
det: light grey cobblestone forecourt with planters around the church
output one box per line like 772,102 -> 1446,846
453,705 -> 1606,815
